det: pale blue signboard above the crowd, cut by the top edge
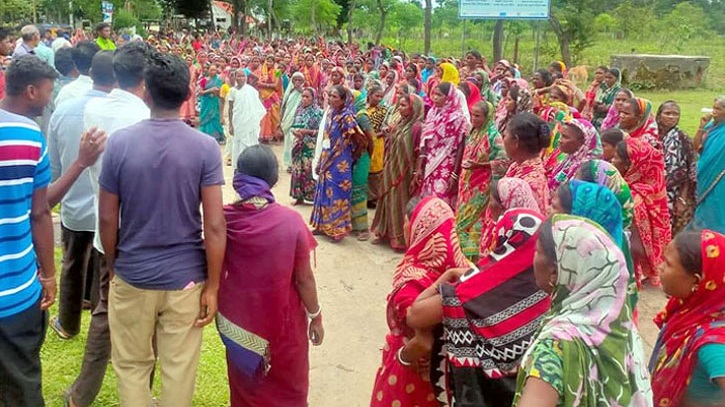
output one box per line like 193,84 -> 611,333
458,0 -> 551,20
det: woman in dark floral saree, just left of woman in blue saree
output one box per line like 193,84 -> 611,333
290,87 -> 322,205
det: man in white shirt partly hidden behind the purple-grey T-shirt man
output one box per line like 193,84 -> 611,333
65,42 -> 151,407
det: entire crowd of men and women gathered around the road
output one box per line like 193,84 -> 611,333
0,21 -> 725,407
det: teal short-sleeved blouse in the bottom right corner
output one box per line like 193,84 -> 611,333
687,343 -> 725,405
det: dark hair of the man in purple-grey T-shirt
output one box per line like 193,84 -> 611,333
144,53 -> 190,110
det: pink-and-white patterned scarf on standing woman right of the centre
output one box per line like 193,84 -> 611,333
420,84 -> 468,178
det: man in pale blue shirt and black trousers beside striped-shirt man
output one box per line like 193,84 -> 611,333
48,51 -> 116,339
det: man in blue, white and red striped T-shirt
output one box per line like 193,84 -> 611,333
0,56 -> 58,407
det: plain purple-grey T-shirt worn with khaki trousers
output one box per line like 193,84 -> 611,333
99,119 -> 224,290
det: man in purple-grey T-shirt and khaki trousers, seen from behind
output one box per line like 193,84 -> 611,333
99,54 -> 226,407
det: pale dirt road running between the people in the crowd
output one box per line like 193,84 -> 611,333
224,146 -> 665,407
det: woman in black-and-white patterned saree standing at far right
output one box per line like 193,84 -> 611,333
655,100 -> 697,236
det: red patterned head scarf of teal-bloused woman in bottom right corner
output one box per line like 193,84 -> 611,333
650,230 -> 725,407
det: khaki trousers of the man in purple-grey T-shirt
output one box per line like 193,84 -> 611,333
108,276 -> 204,407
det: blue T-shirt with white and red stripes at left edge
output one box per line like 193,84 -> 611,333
0,109 -> 50,318
